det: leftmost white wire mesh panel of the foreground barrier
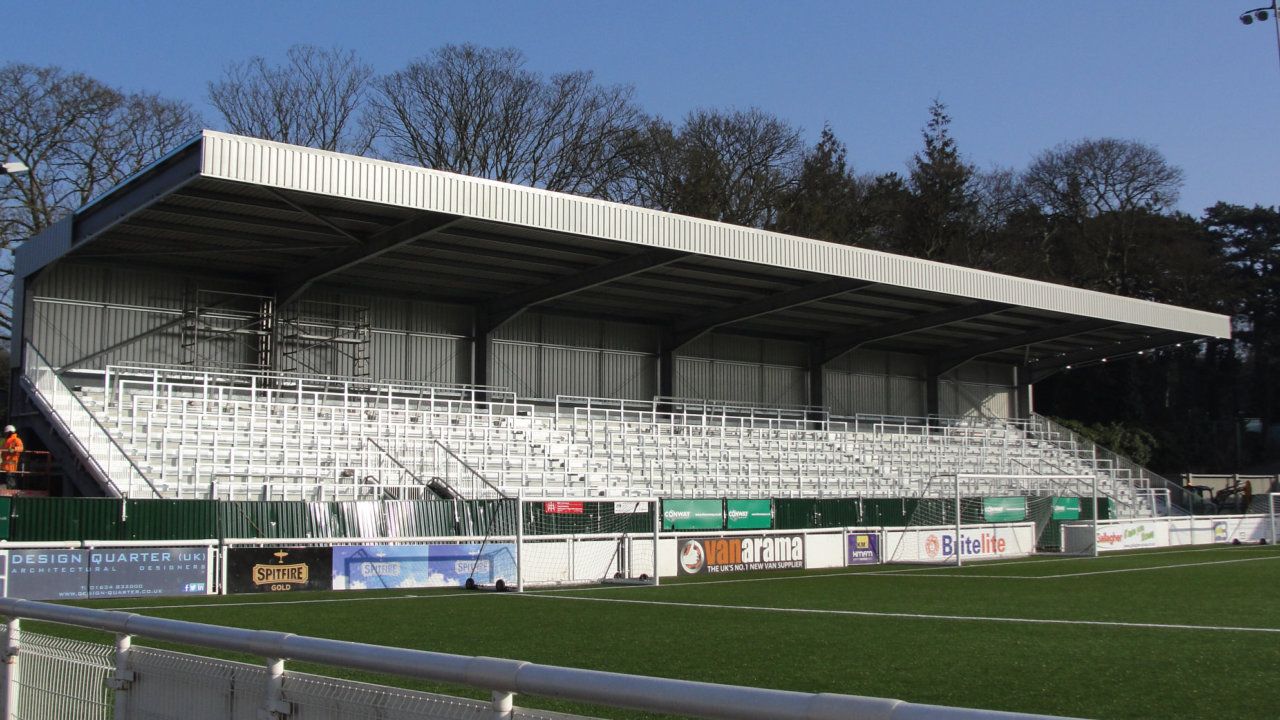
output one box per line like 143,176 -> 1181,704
18,633 -> 114,720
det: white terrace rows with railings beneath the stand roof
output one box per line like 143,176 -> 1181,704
45,365 -> 1151,504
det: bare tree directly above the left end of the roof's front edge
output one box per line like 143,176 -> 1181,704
209,45 -> 374,155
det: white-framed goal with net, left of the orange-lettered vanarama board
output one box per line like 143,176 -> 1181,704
516,497 -> 660,589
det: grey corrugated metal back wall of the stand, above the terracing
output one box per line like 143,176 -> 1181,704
27,258 -> 1014,416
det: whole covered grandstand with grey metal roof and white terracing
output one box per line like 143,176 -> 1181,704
13,132 -> 1229,516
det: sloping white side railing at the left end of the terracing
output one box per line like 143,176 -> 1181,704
23,342 -> 161,497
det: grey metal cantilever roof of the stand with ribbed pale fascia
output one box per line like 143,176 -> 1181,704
18,131 -> 1230,374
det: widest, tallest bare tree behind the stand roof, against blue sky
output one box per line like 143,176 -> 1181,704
374,45 -> 643,199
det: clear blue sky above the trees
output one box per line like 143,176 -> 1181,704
0,0 -> 1280,214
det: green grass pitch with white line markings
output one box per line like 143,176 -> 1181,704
41,546 -> 1280,719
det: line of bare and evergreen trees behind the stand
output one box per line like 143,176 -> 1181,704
0,45 -> 1280,471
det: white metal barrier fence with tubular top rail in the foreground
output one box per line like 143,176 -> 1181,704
0,600 -> 1080,720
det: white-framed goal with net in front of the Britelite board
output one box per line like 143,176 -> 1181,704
884,474 -> 1093,565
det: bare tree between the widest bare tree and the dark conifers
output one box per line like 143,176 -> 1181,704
632,108 -> 804,227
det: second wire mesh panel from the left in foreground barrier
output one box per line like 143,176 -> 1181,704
122,647 -> 266,720
